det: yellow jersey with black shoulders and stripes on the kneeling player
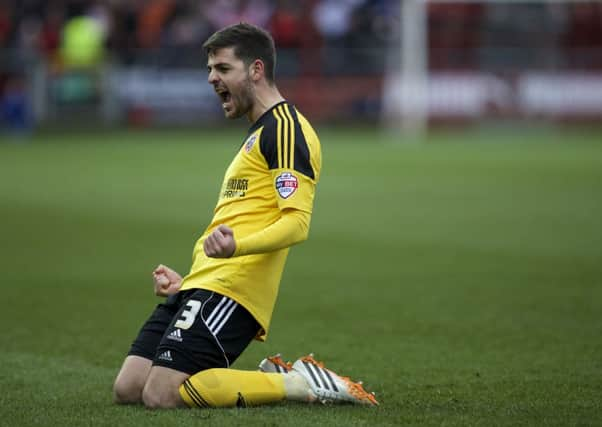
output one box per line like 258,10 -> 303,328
181,101 -> 322,340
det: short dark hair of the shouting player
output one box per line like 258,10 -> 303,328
203,22 -> 276,83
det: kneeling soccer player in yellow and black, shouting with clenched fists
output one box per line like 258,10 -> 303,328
114,23 -> 376,408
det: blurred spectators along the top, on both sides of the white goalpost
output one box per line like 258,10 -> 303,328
0,0 -> 602,74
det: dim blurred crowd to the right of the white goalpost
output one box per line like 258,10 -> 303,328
428,1 -> 602,70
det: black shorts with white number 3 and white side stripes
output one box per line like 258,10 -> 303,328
128,289 -> 260,375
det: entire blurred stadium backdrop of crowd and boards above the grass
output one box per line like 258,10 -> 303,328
0,0 -> 602,130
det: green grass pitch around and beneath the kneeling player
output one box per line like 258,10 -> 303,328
0,125 -> 602,426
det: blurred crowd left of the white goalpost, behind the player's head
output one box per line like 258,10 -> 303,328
0,0 -> 399,71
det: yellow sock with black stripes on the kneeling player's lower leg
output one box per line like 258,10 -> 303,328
180,368 -> 286,408
